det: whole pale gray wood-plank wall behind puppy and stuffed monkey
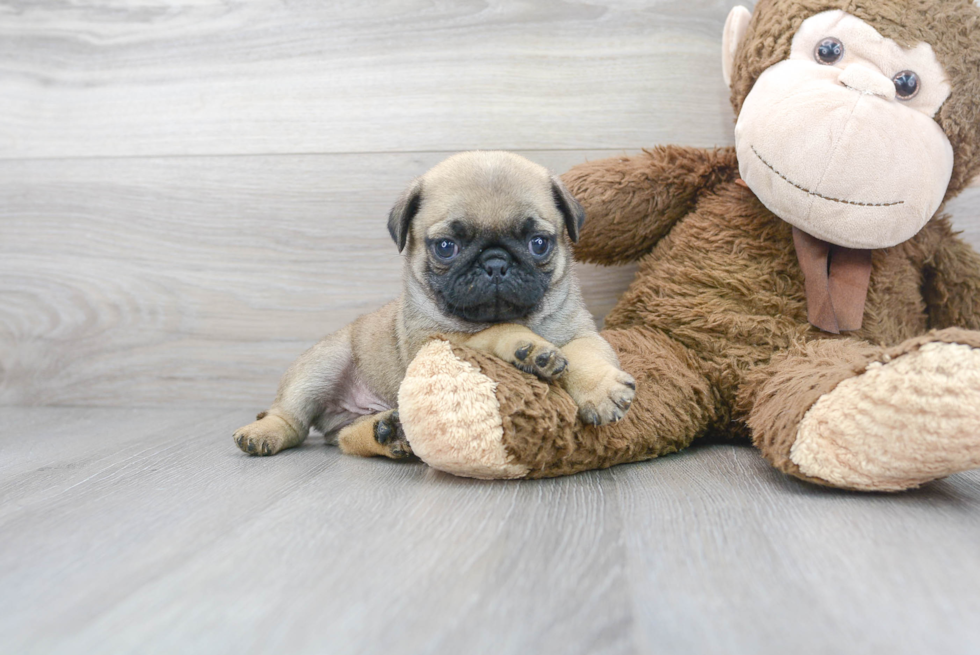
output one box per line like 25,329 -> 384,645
0,0 -> 980,407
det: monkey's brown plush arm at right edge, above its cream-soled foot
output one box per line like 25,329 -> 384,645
923,219 -> 980,330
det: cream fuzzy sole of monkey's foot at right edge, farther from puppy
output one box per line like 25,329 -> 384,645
790,343 -> 980,491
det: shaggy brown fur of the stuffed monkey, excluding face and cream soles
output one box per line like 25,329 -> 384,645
416,0 -> 980,489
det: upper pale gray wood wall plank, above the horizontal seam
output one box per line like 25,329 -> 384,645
0,0 -> 748,158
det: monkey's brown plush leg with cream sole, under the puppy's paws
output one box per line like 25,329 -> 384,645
398,329 -> 719,478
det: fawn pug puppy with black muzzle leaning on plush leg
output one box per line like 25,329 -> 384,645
234,152 -> 636,458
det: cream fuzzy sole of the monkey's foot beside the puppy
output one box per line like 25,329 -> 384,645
398,340 -> 528,479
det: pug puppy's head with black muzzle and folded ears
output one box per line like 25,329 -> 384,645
388,152 -> 584,323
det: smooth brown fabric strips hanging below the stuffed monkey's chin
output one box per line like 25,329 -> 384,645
793,227 -> 871,334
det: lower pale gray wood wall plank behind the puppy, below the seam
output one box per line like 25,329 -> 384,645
0,151 -> 634,409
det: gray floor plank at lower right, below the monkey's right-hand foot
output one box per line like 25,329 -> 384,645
613,446 -> 980,655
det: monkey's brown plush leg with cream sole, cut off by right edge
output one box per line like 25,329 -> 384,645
740,328 -> 980,491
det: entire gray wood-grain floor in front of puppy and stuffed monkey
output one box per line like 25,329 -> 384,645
0,408 -> 980,655
